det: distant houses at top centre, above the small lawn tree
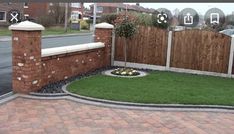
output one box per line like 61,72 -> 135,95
90,3 -> 156,18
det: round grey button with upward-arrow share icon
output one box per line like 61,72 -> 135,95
178,8 -> 199,27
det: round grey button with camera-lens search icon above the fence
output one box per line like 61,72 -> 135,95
155,8 -> 172,28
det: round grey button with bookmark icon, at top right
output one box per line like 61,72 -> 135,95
204,8 -> 225,26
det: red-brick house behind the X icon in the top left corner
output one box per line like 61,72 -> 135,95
0,2 -> 24,26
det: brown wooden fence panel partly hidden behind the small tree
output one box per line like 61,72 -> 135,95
115,26 -> 168,66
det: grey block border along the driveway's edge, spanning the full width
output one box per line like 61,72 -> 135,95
0,93 -> 234,113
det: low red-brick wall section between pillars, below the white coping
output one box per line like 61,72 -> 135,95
42,48 -> 105,86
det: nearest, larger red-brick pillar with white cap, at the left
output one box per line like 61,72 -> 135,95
9,21 -> 44,94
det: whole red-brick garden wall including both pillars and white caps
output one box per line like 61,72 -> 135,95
9,21 -> 113,94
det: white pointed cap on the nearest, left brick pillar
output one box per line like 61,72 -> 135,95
9,21 -> 45,31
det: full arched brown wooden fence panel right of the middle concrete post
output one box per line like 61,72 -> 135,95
171,30 -> 231,73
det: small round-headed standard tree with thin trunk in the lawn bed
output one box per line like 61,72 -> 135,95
115,16 -> 136,68
